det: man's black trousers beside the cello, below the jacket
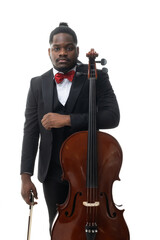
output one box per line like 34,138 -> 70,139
43,179 -> 68,232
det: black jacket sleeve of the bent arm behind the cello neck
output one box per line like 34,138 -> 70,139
71,71 -> 120,130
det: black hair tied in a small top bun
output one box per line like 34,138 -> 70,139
49,22 -> 78,44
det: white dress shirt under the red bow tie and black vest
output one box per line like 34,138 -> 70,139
53,67 -> 76,106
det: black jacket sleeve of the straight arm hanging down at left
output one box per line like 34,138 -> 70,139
20,80 -> 39,175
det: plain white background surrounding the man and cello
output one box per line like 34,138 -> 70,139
0,0 -> 160,240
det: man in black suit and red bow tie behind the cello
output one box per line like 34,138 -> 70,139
21,23 -> 119,232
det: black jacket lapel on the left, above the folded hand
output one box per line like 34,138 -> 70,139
42,69 -> 54,114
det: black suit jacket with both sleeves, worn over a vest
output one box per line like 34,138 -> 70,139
21,65 -> 120,182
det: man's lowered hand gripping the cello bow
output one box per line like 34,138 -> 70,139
21,173 -> 38,205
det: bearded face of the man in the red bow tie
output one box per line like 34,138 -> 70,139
48,33 -> 79,72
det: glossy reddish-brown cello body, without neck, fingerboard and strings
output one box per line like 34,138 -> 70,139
52,131 -> 129,240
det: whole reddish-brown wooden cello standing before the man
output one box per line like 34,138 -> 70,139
51,49 -> 130,240
